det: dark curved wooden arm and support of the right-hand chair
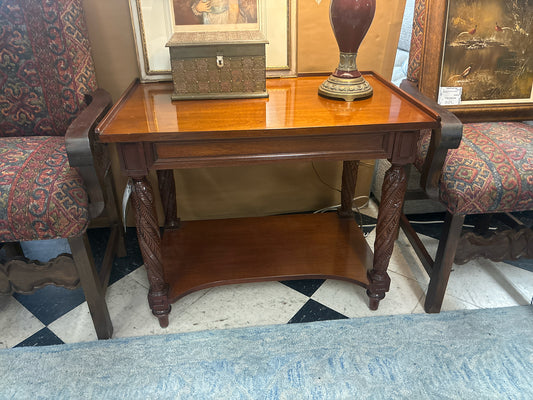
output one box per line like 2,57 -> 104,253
400,80 -> 463,200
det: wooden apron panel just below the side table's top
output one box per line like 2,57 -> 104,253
118,131 -> 418,176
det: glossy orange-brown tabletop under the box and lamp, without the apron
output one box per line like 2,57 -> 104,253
98,73 -> 438,142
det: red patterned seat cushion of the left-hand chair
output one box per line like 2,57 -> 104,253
0,136 -> 89,242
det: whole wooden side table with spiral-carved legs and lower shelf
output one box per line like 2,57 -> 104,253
97,72 -> 439,327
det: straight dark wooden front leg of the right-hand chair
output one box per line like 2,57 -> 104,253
424,212 -> 465,313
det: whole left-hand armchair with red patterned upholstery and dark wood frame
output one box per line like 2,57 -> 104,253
0,0 -> 125,339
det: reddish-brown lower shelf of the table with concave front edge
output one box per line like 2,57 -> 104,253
162,213 -> 373,302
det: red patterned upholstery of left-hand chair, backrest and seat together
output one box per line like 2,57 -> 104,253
0,0 -> 96,242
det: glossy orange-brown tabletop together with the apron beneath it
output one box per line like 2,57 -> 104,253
97,74 -> 439,170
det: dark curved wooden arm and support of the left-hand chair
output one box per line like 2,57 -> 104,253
65,89 -> 112,218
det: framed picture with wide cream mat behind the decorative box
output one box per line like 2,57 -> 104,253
130,0 -> 296,81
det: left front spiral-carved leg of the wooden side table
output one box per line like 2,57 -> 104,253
132,176 -> 170,328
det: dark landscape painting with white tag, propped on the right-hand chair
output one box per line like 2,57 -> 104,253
419,0 -> 533,121
